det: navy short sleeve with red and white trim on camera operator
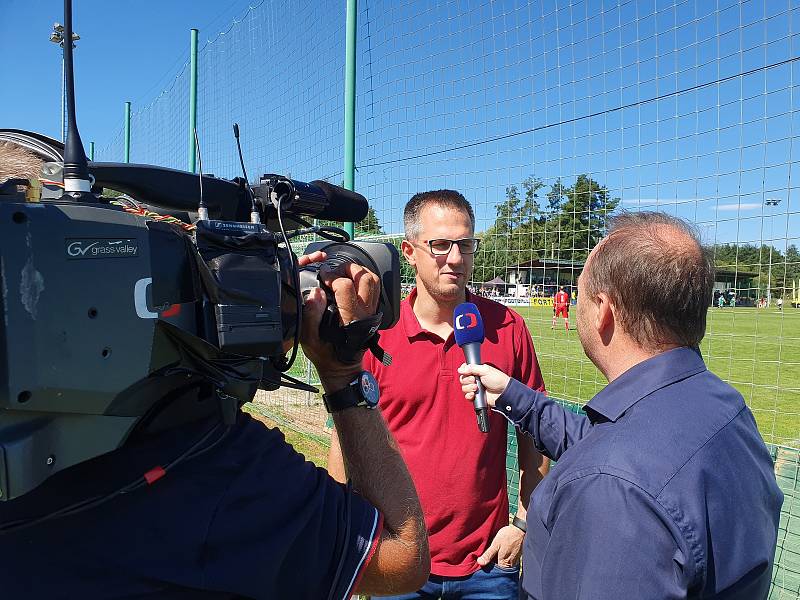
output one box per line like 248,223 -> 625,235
199,423 -> 382,600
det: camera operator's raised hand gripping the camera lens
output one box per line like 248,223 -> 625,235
298,252 -> 380,392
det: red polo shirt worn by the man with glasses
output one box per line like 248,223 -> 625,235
364,290 -> 544,577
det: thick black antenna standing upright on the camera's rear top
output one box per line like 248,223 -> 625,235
61,0 -> 95,202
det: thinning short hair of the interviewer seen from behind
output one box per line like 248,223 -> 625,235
583,212 -> 714,349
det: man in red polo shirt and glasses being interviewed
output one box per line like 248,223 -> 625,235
328,190 -> 548,600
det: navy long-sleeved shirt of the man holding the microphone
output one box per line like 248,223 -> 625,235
496,348 -> 783,600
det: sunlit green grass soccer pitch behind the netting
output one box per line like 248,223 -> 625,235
513,306 -> 800,448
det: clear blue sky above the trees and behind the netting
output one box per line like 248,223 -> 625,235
0,0 -> 800,248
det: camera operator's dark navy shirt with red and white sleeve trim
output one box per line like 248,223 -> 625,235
0,414 -> 382,600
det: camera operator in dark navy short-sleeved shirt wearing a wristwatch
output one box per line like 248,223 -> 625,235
0,142 -> 430,600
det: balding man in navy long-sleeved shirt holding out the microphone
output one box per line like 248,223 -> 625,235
459,213 -> 783,600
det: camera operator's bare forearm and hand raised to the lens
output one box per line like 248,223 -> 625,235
300,253 -> 430,594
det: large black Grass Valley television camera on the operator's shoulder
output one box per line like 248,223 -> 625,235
0,151 -> 400,500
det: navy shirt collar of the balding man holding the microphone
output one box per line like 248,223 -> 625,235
583,348 -> 706,422
